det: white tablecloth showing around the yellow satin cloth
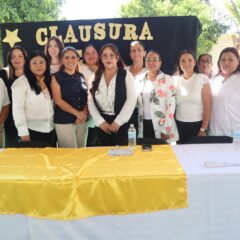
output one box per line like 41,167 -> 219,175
0,144 -> 240,240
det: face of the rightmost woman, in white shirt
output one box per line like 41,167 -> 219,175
219,52 -> 239,76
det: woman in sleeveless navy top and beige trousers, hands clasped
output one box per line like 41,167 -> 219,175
51,47 -> 88,148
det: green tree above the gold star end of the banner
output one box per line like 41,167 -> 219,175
0,0 -> 65,65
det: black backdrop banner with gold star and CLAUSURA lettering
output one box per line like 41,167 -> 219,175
1,16 -> 201,74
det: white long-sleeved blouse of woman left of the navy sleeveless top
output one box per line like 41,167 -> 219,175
12,75 -> 53,136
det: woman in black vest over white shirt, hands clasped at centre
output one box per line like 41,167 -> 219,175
88,44 -> 137,146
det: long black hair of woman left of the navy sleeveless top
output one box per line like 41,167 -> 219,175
25,51 -> 50,95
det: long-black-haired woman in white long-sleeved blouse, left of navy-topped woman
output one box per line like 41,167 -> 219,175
12,51 -> 55,146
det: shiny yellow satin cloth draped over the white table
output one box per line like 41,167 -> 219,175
0,145 -> 187,219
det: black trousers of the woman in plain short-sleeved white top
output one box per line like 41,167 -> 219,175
176,120 -> 202,144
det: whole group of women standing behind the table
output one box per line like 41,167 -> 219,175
0,37 -> 240,148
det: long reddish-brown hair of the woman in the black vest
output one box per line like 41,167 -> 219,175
90,43 -> 124,96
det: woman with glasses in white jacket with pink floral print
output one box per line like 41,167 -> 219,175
139,50 -> 178,143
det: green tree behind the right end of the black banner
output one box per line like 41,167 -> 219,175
120,0 -> 228,53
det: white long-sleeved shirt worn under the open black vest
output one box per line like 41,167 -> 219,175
88,71 -> 137,126
